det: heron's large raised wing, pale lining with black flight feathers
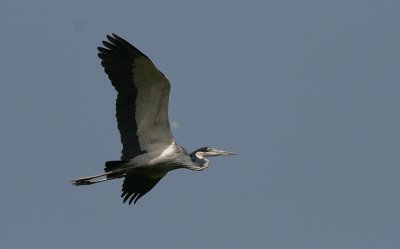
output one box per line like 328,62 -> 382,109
98,34 -> 173,160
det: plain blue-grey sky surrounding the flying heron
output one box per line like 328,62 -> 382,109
0,0 -> 400,249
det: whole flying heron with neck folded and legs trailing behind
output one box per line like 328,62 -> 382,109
71,34 -> 235,205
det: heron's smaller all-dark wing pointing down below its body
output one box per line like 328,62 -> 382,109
121,173 -> 166,205
